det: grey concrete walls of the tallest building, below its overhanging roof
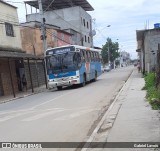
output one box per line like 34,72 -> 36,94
26,6 -> 92,47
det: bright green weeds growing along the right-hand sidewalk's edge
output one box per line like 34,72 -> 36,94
144,73 -> 160,110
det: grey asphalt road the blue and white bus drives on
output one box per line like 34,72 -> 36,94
0,67 -> 133,149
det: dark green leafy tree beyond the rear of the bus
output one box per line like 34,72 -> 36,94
102,38 -> 119,64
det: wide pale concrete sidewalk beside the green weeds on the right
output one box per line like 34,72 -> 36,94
88,70 -> 160,151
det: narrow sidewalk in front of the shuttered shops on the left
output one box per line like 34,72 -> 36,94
0,85 -> 48,104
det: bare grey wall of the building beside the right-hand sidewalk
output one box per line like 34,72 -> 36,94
136,28 -> 160,73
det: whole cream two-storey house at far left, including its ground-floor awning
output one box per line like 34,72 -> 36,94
0,1 -> 45,97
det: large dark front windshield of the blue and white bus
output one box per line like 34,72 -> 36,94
47,52 -> 81,74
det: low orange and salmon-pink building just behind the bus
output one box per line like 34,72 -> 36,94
21,21 -> 72,56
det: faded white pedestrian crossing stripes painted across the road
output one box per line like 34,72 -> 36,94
0,108 -> 100,123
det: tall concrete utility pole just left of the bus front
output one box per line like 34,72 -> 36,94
38,0 -> 48,89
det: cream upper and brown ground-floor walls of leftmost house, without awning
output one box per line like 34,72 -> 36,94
0,1 -> 22,96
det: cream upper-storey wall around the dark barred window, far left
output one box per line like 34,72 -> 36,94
0,1 -> 22,50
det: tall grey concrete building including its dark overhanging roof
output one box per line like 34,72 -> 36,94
25,0 -> 94,47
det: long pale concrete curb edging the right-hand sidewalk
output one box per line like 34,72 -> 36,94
81,70 -> 133,151
